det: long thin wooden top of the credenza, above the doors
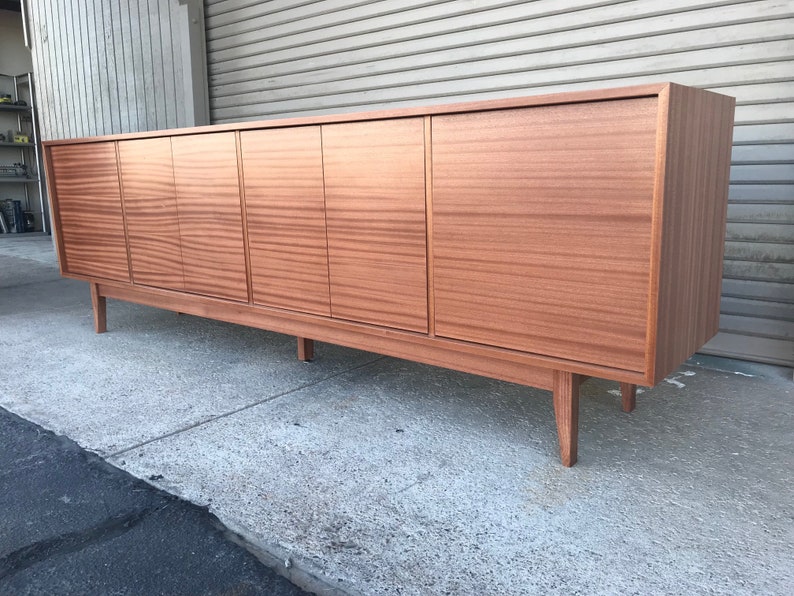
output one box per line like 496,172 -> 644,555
43,83 -> 692,146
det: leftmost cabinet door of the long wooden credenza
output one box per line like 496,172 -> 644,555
49,142 -> 130,281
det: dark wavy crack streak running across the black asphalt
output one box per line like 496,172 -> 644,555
0,503 -> 168,580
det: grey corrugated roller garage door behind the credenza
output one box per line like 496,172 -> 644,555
205,0 -> 794,366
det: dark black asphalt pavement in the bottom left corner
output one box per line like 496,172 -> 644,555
0,408 -> 308,596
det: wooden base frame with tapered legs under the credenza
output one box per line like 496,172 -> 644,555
89,280 -> 643,467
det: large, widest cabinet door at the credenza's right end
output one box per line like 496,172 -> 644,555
432,98 -> 657,371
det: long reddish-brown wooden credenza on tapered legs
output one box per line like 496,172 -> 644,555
45,84 -> 734,465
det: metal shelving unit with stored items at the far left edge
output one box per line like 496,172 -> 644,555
0,72 -> 50,233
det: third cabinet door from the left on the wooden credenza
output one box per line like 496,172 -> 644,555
171,132 -> 248,301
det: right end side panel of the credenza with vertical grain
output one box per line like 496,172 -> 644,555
653,85 -> 735,382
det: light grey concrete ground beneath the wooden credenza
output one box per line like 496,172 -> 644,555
0,238 -> 794,595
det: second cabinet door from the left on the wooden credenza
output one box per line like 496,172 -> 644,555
119,137 -> 185,290
